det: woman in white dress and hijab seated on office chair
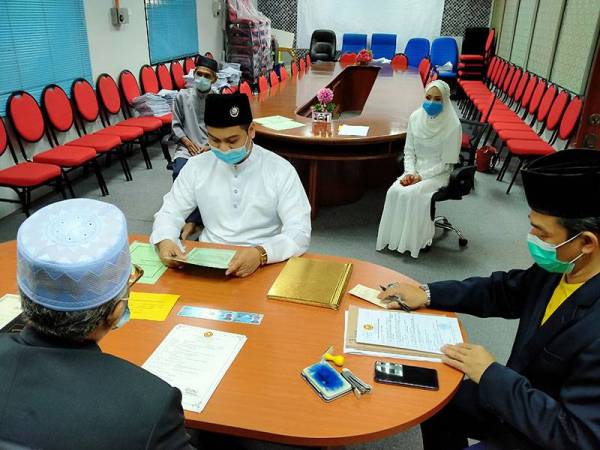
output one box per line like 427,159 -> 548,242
377,80 -> 462,258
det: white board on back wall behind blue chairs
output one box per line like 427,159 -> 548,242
297,0 -> 444,52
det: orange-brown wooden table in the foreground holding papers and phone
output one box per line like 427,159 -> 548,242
0,235 -> 462,447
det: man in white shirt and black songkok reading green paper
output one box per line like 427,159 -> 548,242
150,94 -> 311,277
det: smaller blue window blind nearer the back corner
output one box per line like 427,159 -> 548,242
145,0 -> 198,64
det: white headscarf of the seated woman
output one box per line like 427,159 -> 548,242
409,80 -> 461,164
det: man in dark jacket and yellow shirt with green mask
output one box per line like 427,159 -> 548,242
380,150 -> 600,450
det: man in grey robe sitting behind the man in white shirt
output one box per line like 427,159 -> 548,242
172,55 -> 218,239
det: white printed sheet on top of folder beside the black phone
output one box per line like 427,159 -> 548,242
356,309 -> 463,354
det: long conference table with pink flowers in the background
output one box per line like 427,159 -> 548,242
251,62 -> 423,218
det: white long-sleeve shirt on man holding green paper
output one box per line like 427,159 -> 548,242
150,144 -> 311,263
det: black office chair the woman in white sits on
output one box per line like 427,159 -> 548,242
431,164 -> 475,247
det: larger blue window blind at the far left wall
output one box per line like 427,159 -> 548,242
0,0 -> 92,115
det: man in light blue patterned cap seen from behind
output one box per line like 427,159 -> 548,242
0,199 -> 191,450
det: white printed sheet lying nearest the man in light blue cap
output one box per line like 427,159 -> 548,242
142,324 -> 246,412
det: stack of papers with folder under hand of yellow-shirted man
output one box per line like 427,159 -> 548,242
344,306 -> 463,361
